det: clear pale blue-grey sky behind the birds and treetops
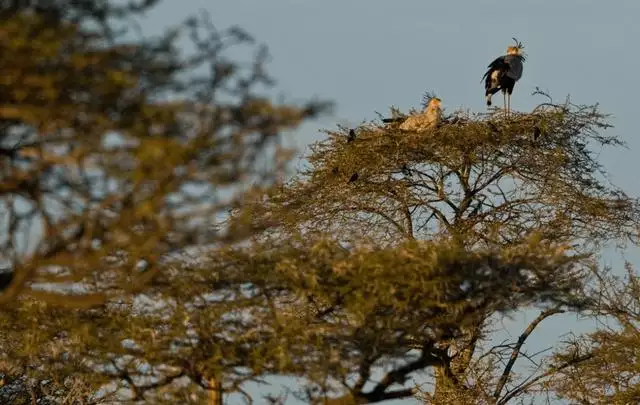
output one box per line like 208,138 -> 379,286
144,0 -> 640,403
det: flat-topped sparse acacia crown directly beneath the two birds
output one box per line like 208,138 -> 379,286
253,103 -> 640,249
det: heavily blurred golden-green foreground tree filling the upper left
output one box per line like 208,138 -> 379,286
0,1 -> 323,305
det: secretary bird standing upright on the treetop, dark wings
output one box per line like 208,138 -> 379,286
482,38 -> 525,114
